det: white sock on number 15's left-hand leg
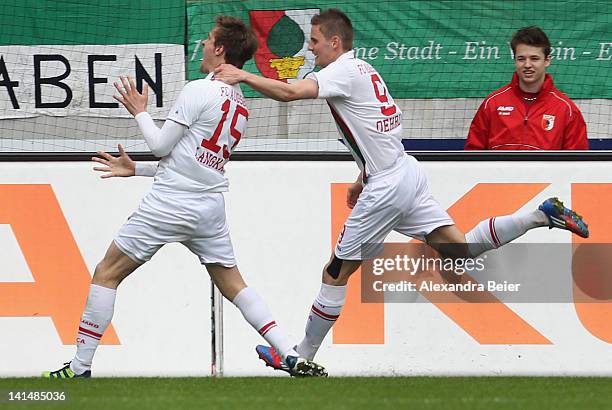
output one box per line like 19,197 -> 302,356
70,284 -> 117,374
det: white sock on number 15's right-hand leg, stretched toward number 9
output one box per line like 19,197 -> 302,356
232,287 -> 298,360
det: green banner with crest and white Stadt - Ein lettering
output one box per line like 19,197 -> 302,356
187,0 -> 612,99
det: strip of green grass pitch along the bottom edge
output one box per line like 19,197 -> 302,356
0,377 -> 612,410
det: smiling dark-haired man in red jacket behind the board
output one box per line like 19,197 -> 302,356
465,26 -> 589,150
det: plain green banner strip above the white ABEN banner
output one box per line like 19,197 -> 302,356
0,0 -> 185,46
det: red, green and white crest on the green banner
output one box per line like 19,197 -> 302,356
249,9 -> 320,82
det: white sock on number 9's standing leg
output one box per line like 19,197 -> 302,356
296,283 -> 346,360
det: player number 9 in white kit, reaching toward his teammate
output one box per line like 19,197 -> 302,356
215,9 -> 588,370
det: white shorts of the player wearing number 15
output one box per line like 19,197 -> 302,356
115,190 -> 236,267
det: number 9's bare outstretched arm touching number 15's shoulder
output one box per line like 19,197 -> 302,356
215,64 -> 319,101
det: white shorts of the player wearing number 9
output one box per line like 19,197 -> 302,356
335,155 -> 455,260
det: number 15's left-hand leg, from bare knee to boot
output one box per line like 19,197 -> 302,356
43,242 -> 140,379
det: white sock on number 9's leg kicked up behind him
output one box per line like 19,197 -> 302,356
465,209 -> 548,257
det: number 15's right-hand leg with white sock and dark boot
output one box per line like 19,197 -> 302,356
206,264 -> 327,377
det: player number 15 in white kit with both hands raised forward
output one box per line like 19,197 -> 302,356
43,16 -> 327,378
